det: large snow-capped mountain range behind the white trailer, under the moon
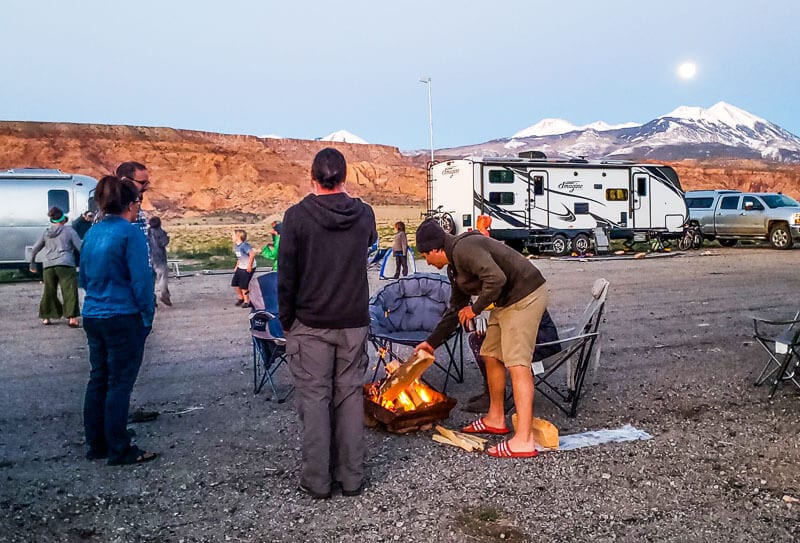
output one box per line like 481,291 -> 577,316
440,102 -> 800,162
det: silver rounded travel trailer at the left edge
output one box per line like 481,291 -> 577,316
0,168 -> 97,270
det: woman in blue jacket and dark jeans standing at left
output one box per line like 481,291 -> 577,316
79,175 -> 157,466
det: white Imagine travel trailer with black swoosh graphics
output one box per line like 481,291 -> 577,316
428,154 -> 689,254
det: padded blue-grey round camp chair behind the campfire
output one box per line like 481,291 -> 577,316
369,273 -> 464,392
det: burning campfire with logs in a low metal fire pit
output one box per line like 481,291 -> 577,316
364,351 -> 456,434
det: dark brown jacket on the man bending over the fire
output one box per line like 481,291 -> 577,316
427,232 -> 545,347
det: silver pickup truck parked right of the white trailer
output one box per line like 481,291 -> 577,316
684,190 -> 800,249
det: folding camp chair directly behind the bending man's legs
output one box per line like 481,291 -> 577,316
531,279 -> 609,417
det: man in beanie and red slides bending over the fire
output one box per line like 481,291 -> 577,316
415,219 -> 547,458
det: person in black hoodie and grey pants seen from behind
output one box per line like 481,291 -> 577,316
278,148 -> 378,498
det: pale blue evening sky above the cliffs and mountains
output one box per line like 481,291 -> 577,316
0,0 -> 800,150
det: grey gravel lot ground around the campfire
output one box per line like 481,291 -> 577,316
0,248 -> 800,542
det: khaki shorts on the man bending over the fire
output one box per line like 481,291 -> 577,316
481,285 -> 547,368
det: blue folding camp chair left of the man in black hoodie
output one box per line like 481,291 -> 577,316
250,272 -> 294,403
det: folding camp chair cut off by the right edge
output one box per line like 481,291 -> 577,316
753,311 -> 800,398
